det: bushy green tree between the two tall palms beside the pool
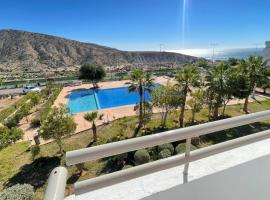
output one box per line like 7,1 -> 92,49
152,83 -> 180,128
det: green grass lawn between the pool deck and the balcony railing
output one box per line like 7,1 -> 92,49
0,100 -> 270,199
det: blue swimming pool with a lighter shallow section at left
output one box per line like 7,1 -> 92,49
68,85 -> 154,114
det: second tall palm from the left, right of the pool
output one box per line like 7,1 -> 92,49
175,66 -> 201,127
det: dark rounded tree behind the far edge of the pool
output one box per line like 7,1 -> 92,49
79,64 -> 106,88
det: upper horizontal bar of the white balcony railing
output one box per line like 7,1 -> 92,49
66,110 -> 270,166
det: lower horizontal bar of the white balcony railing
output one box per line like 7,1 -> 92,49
75,130 -> 270,194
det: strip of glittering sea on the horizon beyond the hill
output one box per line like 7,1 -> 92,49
169,48 -> 264,60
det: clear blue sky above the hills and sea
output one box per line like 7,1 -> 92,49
0,0 -> 270,50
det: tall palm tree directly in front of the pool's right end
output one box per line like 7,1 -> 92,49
128,69 -> 154,130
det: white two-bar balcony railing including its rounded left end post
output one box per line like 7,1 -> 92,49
44,110 -> 270,200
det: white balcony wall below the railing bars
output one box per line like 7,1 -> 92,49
66,139 -> 270,200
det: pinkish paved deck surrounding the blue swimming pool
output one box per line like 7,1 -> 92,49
54,76 -> 172,133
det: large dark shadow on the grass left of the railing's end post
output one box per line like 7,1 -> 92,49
5,157 -> 61,190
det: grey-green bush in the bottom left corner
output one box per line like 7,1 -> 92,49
0,184 -> 34,200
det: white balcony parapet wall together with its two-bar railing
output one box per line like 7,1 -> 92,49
45,110 -> 270,200
